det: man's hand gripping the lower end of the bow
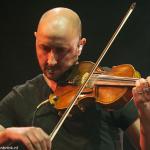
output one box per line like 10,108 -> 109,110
2,127 -> 51,150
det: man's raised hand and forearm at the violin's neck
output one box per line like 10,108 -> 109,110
133,77 -> 150,150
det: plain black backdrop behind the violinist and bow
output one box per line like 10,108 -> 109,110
0,0 -> 150,98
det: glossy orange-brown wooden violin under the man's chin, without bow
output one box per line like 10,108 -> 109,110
49,61 -> 140,111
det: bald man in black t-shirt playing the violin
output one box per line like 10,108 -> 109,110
0,8 -> 150,150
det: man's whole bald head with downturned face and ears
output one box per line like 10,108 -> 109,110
35,7 -> 86,79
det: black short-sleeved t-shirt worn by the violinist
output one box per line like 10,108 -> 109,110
0,75 -> 138,150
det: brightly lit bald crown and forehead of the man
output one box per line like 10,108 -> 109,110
37,7 -> 81,37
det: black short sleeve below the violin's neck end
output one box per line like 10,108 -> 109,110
112,100 -> 139,130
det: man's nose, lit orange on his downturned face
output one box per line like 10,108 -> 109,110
47,50 -> 57,66
